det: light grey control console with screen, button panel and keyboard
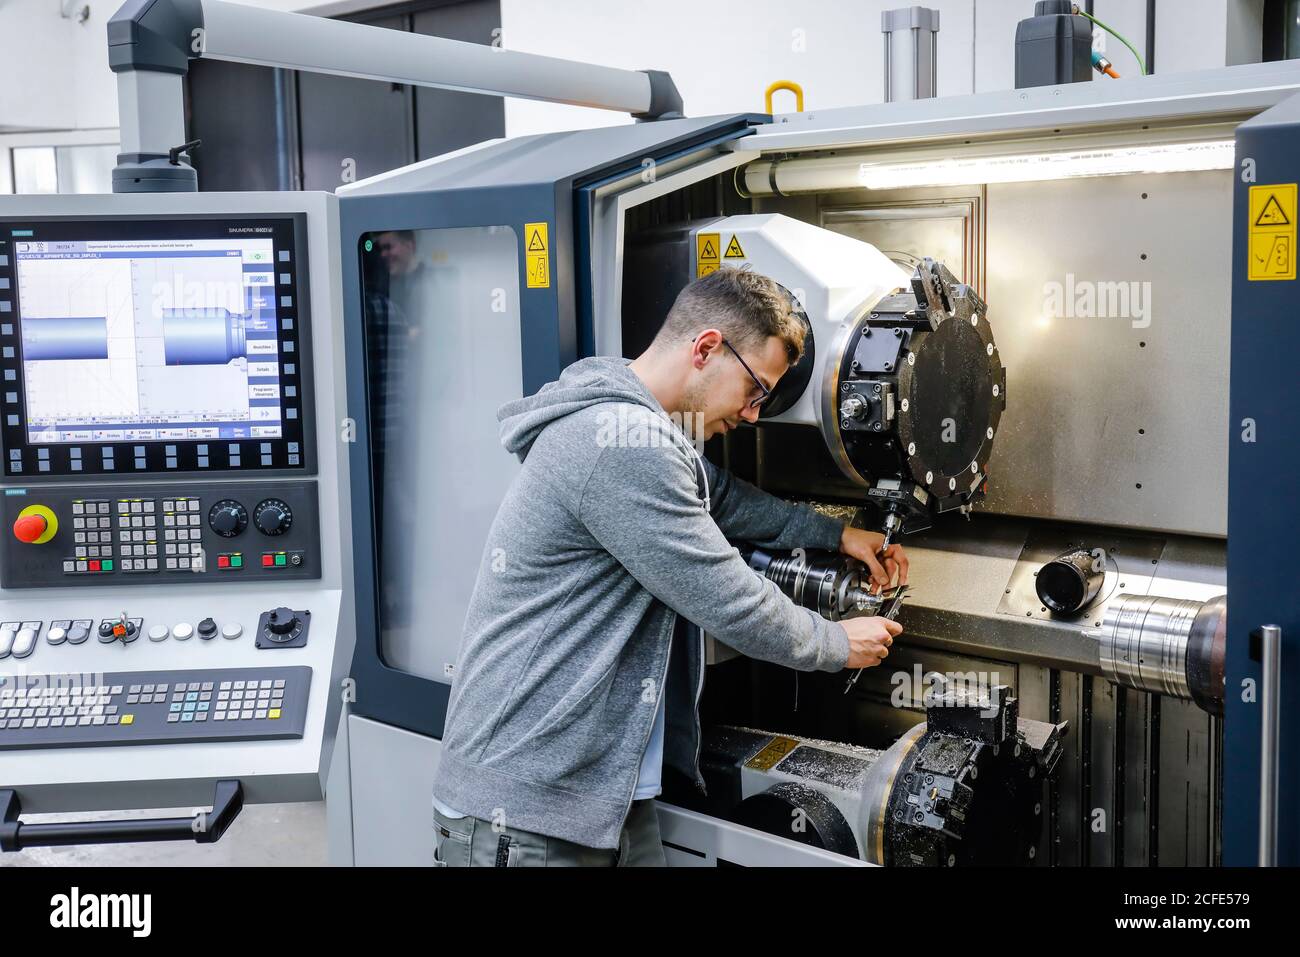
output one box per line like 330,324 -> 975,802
0,192 -> 354,850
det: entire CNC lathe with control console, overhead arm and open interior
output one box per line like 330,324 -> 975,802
0,0 -> 1300,866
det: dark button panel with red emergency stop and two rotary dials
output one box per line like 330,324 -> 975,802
0,481 -> 320,588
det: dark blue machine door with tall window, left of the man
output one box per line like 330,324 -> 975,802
339,116 -> 766,738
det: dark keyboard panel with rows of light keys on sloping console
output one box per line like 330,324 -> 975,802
0,666 -> 312,750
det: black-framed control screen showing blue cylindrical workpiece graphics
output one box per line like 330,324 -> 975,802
0,217 -> 308,476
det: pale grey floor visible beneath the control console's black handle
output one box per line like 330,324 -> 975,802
0,801 -> 325,867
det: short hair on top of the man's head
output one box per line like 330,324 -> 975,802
655,267 -> 807,365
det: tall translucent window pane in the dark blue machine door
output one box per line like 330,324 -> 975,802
360,226 -> 523,681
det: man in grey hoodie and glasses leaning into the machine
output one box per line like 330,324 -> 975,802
433,269 -> 907,866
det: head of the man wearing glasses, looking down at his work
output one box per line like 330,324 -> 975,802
646,268 -> 805,438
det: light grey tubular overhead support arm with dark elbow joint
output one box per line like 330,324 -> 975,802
108,0 -> 683,191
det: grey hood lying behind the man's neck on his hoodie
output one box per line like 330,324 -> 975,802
497,355 -> 664,462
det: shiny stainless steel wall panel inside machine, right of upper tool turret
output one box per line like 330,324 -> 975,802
983,170 -> 1231,536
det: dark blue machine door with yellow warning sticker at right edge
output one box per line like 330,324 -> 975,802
1223,96 -> 1300,866
